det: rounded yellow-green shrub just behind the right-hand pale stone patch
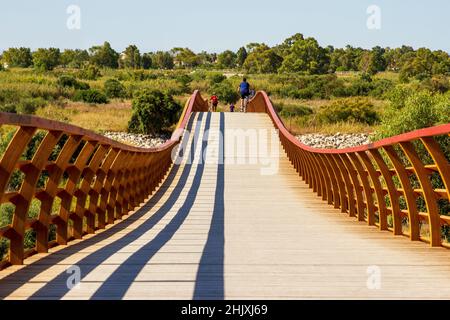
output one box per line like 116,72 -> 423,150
317,98 -> 379,125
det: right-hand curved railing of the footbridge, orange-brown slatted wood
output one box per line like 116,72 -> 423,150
247,91 -> 450,247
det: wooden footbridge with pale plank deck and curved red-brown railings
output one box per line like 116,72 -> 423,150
0,92 -> 450,299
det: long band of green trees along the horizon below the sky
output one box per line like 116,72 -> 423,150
0,33 -> 450,81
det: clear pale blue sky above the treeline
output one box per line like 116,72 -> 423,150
0,0 -> 450,52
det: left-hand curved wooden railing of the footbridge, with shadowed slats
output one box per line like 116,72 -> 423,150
0,91 -> 208,269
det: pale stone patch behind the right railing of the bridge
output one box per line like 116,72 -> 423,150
297,132 -> 371,149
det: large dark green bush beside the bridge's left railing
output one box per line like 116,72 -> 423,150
128,89 -> 181,134
